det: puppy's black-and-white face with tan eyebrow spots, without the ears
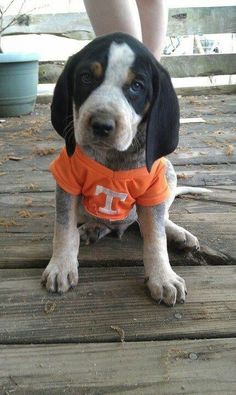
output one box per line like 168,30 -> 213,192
73,42 -> 152,151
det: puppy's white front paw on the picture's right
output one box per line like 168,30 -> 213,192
147,270 -> 187,306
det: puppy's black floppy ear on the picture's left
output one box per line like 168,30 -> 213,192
51,57 -> 76,156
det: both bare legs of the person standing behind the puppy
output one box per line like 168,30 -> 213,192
84,0 -> 168,60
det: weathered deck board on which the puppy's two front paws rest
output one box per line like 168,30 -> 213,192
0,266 -> 236,344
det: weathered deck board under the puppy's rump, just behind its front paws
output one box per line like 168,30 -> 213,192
0,195 -> 236,268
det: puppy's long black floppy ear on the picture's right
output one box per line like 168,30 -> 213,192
146,64 -> 179,171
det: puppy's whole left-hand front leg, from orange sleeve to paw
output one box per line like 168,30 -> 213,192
42,186 -> 79,293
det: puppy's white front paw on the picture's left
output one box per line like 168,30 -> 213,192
41,258 -> 79,293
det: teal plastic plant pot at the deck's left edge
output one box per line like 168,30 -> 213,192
0,52 -> 38,117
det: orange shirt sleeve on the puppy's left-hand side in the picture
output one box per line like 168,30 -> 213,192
49,148 -> 81,195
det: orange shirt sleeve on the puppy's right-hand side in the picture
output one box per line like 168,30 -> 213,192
136,158 -> 169,206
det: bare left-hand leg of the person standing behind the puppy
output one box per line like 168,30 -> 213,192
84,0 -> 142,41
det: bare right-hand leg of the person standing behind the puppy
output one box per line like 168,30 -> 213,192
136,0 -> 168,60
